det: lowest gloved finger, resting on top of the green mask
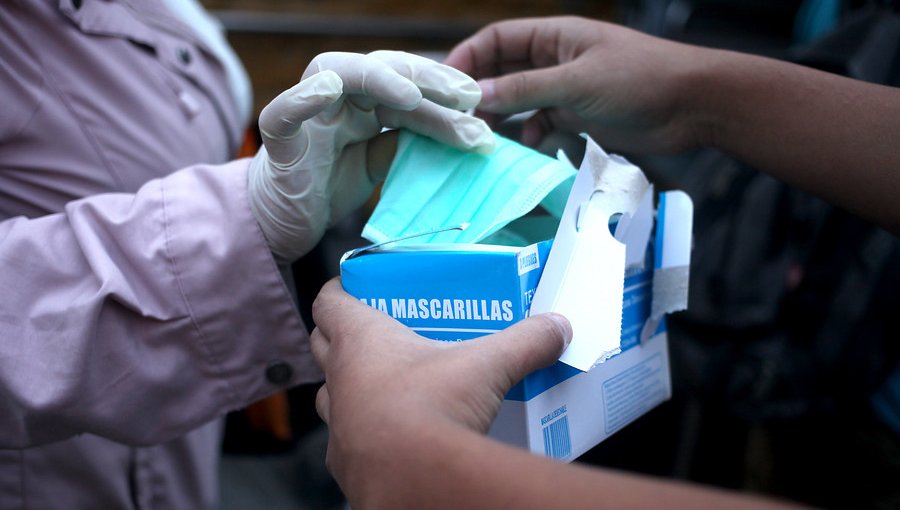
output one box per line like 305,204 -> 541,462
376,101 -> 497,154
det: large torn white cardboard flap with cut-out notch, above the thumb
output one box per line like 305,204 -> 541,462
531,138 -> 652,371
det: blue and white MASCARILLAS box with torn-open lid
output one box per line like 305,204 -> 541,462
341,140 -> 692,460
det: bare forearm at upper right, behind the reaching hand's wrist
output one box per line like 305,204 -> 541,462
685,51 -> 900,233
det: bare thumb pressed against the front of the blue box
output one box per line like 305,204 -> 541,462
477,313 -> 572,385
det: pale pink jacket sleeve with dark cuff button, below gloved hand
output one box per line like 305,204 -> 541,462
0,160 -> 321,448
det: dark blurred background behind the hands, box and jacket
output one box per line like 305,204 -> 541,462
202,0 -> 900,510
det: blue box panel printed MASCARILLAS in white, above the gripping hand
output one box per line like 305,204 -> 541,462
341,241 -> 551,340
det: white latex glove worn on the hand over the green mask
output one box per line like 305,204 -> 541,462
249,51 -> 494,265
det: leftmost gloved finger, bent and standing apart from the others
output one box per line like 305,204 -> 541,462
259,70 -> 343,170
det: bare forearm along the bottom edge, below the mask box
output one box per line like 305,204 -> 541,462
349,423 -> 804,510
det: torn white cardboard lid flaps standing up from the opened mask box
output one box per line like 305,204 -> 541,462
531,136 -> 693,371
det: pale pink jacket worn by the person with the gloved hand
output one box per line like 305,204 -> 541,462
0,0 -> 320,509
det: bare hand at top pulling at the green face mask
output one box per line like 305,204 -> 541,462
445,17 -> 709,152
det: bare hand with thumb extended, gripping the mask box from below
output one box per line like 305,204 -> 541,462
311,279 -> 572,493
